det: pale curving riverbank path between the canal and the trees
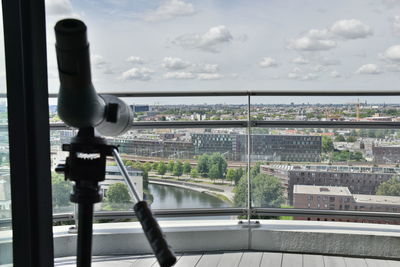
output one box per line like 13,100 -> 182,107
149,177 -> 234,204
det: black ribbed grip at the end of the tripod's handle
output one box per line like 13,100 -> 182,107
133,201 -> 176,267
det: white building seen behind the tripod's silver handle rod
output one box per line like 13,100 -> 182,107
100,166 -> 143,202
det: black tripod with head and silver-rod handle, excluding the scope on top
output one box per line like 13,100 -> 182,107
56,127 -> 176,267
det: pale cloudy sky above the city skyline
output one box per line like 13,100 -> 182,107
41,0 -> 400,103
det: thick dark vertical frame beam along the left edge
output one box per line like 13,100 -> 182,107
2,0 -> 54,267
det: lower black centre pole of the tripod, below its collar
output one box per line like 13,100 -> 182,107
77,203 -> 93,267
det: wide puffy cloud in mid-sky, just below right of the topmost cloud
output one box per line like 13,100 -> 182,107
173,25 -> 233,53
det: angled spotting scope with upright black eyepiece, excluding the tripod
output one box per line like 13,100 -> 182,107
55,19 -> 133,136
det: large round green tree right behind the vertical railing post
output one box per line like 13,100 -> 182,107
234,173 -> 284,208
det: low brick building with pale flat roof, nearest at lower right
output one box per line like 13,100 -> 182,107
293,185 -> 400,224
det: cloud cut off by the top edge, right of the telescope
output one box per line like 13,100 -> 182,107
144,0 -> 195,22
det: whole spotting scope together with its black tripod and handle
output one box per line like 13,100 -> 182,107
55,19 -> 176,267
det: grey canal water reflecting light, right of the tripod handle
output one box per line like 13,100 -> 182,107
149,184 -> 231,220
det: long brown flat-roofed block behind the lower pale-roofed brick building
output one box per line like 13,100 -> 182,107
260,165 -> 399,204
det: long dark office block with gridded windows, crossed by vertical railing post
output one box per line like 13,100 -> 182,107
192,133 -> 321,162
